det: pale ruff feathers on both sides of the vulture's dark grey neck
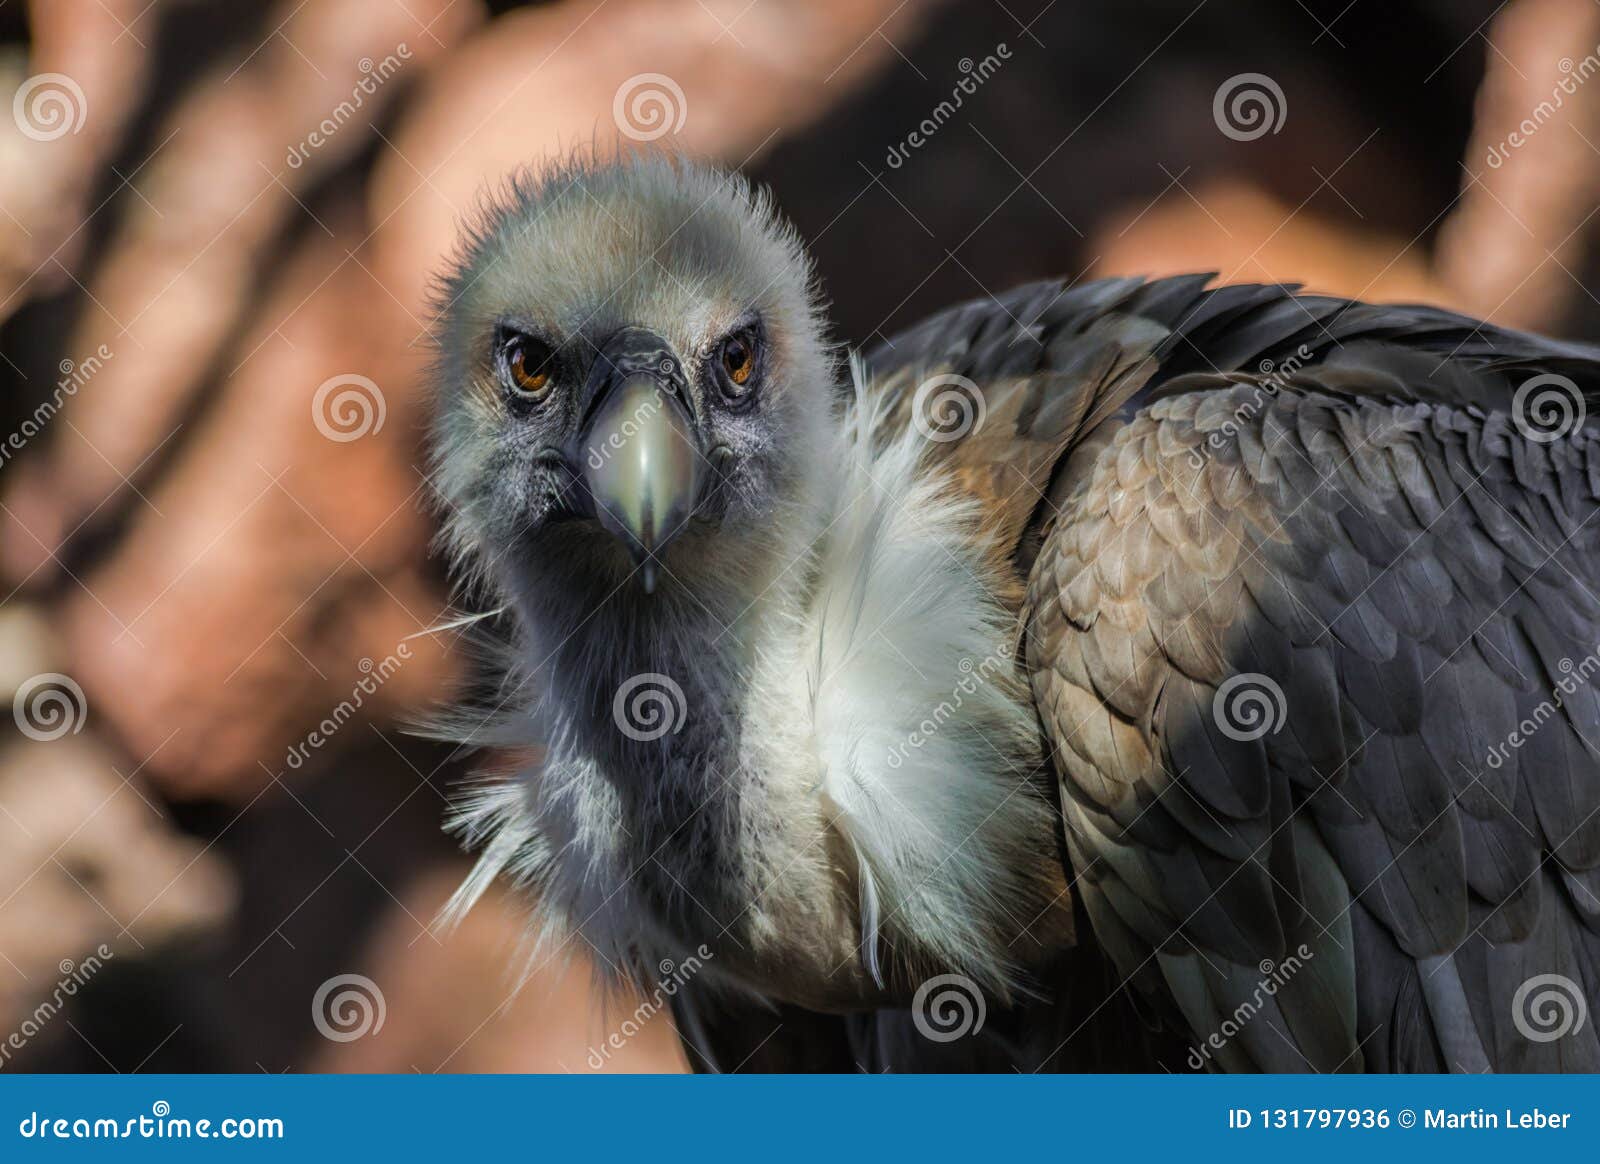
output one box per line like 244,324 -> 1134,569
453,368 -> 1056,996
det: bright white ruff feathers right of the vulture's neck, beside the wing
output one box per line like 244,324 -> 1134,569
755,366 -> 1054,987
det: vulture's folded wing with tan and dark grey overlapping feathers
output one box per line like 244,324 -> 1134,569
889,280 -> 1600,1071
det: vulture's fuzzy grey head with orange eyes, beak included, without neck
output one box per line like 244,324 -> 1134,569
440,160 -> 837,601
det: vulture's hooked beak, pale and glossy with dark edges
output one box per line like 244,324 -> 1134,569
582,328 -> 706,593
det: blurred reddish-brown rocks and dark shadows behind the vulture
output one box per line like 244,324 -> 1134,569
0,0 -> 1600,1071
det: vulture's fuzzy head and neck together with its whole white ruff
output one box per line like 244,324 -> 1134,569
434,155 -> 1059,1007
